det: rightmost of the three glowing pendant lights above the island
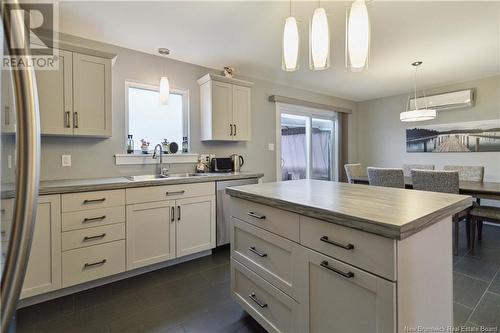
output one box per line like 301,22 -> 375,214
345,0 -> 370,72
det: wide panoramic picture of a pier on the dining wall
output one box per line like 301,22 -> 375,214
406,119 -> 500,153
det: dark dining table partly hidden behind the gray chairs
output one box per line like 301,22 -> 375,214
351,176 -> 500,200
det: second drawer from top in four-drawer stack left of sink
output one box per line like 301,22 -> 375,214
62,206 -> 125,231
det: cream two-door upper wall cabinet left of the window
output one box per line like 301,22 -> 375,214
36,50 -> 112,137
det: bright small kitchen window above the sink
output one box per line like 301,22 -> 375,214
125,82 -> 189,151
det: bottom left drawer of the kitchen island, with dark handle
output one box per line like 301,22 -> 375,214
231,259 -> 300,332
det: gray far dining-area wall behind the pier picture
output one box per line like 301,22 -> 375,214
351,76 -> 500,181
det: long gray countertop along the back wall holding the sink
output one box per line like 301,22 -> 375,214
1,172 -> 264,199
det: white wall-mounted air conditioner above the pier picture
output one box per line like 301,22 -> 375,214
409,88 -> 476,110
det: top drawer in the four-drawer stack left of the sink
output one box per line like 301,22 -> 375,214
62,190 -> 125,212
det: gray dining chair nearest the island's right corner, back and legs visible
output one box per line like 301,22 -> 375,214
411,169 -> 472,255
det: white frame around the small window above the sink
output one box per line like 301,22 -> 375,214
123,80 -> 191,154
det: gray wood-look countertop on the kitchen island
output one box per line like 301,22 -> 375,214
226,179 -> 472,240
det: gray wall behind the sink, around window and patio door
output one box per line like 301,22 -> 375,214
34,36 -> 356,181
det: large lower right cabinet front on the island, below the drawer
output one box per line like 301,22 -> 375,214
300,248 -> 396,333
